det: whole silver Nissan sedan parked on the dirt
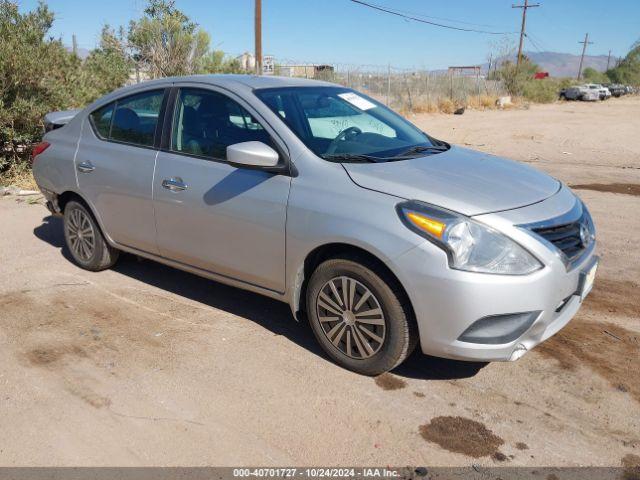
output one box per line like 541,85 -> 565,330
33,75 -> 598,375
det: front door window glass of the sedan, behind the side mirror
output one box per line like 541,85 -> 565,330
171,88 -> 272,160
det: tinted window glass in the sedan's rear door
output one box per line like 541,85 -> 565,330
109,90 -> 164,146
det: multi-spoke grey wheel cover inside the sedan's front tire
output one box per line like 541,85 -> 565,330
316,276 -> 386,360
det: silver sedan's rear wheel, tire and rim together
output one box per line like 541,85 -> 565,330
64,200 -> 120,272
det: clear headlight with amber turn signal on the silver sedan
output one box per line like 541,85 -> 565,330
397,201 -> 543,275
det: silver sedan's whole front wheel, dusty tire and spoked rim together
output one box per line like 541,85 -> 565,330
306,257 -> 418,376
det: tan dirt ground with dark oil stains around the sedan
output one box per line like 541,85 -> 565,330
0,97 -> 640,466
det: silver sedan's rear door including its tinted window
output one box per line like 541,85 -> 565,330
75,88 -> 168,253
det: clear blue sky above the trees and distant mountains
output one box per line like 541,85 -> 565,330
19,0 -> 640,69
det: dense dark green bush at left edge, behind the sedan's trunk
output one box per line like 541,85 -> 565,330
0,0 -> 131,173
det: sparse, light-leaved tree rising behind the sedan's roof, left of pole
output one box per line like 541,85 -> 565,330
129,0 -> 209,78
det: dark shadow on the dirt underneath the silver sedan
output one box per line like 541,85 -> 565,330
33,216 -> 486,380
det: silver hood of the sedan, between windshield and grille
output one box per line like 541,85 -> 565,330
343,146 -> 560,215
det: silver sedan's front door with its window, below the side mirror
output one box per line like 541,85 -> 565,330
154,87 -> 291,292
